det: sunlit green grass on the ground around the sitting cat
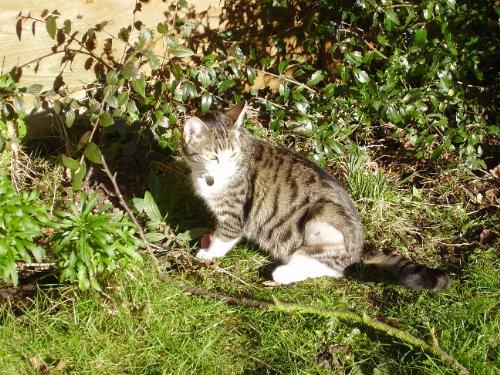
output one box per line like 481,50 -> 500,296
0,149 -> 500,374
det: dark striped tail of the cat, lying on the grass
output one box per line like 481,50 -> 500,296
364,253 -> 450,290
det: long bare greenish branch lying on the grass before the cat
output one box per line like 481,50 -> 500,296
168,279 -> 469,375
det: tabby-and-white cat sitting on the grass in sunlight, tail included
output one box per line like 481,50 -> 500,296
182,102 -> 449,290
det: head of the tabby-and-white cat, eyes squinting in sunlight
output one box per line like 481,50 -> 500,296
182,102 -> 246,168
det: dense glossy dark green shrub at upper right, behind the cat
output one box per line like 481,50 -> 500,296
252,0 -> 499,169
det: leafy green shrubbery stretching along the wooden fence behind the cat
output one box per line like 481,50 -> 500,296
11,0 -> 499,173
